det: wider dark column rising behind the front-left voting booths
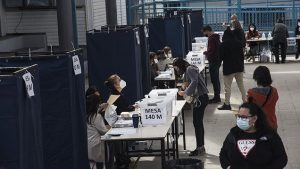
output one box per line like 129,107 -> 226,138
57,0 -> 78,50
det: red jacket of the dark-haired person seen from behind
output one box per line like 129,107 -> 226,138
248,87 -> 279,129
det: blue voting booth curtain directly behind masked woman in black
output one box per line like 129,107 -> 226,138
87,28 -> 143,104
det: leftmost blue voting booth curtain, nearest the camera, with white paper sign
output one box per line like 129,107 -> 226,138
0,65 -> 44,169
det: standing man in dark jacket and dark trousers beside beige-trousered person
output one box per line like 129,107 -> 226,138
202,25 -> 221,103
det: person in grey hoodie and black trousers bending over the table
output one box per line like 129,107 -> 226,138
173,58 -> 208,156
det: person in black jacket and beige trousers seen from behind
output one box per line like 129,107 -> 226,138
218,29 -> 246,110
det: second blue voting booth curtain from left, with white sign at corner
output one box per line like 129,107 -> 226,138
0,53 -> 89,169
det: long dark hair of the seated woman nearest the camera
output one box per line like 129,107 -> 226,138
86,87 -> 101,124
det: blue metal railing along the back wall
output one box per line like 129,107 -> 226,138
128,0 -> 300,33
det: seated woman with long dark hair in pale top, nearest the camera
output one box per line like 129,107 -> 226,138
86,87 -> 108,169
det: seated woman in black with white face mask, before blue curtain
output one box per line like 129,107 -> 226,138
105,74 -> 135,115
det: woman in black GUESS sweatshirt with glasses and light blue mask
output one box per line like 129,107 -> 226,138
220,103 -> 288,169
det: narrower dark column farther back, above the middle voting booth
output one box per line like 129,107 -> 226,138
105,0 -> 118,25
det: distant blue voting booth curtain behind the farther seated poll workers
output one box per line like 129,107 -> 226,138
148,17 -> 186,57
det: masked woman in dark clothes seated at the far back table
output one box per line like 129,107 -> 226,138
246,23 -> 260,61
